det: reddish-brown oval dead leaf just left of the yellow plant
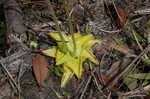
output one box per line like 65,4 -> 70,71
32,54 -> 48,85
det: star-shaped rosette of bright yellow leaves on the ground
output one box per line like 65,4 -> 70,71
42,32 -> 100,87
